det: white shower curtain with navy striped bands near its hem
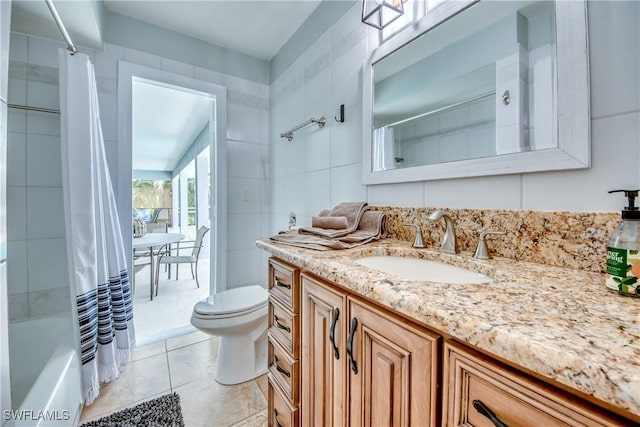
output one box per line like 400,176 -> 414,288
58,49 -> 135,405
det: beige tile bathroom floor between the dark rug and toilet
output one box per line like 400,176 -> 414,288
81,331 -> 267,427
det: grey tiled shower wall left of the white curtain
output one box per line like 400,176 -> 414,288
7,34 -> 71,321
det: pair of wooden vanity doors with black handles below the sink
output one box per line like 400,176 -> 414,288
300,273 -> 439,427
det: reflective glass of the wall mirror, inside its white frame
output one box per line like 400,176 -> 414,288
371,1 -> 558,171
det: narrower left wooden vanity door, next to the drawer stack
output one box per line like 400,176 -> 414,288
300,275 -> 346,427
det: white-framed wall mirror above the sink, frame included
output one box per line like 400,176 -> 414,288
363,0 -> 590,184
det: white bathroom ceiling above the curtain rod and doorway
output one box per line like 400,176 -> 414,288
11,0 -> 321,61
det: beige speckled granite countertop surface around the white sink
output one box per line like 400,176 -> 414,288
256,239 -> 640,416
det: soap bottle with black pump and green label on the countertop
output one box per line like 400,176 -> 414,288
606,190 -> 640,297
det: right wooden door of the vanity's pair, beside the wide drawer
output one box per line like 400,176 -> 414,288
347,298 -> 439,427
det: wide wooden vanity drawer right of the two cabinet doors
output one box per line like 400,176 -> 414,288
442,343 -> 622,427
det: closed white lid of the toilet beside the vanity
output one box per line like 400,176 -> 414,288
193,285 -> 269,316
